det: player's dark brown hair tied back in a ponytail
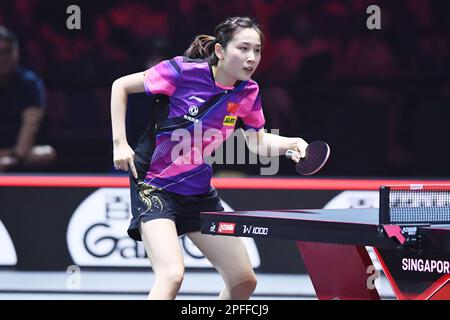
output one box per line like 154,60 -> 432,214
184,17 -> 264,65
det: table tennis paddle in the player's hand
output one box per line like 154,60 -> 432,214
286,140 -> 331,176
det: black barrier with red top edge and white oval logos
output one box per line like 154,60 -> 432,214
0,176 -> 448,274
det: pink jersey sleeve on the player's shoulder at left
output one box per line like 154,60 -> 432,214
144,57 -> 183,97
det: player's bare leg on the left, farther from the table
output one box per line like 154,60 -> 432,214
140,219 -> 184,299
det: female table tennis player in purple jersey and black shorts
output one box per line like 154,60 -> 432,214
111,17 -> 308,299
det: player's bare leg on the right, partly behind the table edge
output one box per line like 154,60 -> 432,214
187,232 -> 256,299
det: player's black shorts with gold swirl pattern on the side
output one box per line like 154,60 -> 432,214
128,177 -> 224,241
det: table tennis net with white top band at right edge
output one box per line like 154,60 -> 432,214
380,184 -> 450,225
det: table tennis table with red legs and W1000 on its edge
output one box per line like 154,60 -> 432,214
201,208 -> 450,300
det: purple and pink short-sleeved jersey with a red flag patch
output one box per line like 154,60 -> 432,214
144,56 -> 265,195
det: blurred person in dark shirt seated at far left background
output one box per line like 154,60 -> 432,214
0,26 -> 56,172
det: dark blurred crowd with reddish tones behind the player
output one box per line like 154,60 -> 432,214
0,0 -> 450,177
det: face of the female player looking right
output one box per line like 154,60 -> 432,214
221,28 -> 261,82
